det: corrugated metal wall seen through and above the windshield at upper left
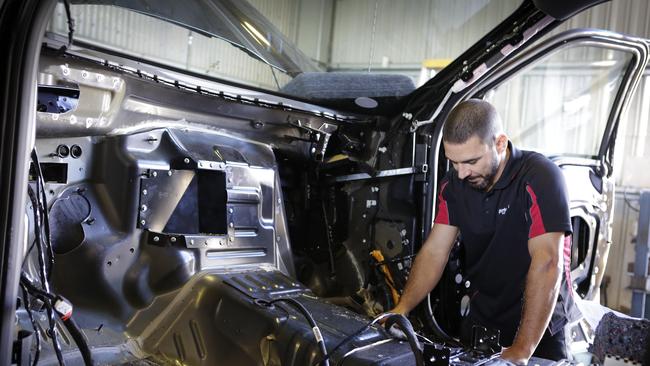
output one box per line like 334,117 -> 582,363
49,0 -> 299,89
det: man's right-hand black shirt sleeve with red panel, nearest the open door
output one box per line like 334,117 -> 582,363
525,157 -> 572,239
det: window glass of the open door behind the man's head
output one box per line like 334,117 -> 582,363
488,46 -> 631,158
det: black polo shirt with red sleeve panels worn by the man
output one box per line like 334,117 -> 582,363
435,143 -> 573,346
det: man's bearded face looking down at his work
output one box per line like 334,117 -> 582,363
444,136 -> 498,190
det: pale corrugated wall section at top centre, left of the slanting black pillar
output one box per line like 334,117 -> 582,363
331,0 -> 521,70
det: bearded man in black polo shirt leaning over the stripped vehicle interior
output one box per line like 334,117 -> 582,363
392,99 -> 574,364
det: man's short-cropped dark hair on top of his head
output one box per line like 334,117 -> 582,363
442,99 -> 501,146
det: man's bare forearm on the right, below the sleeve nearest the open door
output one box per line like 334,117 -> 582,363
510,254 -> 562,357
